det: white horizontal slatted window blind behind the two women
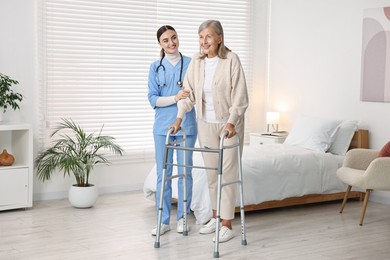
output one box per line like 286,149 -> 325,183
38,0 -> 253,161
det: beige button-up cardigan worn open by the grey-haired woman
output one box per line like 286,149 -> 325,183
177,52 -> 249,125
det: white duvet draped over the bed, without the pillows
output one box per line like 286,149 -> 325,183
143,144 -> 345,224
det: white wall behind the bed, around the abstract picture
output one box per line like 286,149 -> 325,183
267,0 -> 390,203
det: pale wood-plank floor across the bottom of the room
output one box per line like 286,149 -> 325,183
0,192 -> 390,260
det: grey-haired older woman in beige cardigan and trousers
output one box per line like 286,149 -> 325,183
170,20 -> 248,242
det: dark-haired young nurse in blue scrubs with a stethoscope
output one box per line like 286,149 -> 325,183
148,25 -> 197,236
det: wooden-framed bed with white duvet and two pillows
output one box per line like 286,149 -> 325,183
143,116 -> 368,224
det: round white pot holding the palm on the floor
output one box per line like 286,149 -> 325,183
68,184 -> 99,208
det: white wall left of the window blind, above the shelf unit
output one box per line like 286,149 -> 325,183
0,0 -> 37,124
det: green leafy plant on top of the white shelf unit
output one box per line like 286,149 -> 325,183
0,73 -> 23,118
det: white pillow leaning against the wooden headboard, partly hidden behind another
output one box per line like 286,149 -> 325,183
328,120 -> 358,155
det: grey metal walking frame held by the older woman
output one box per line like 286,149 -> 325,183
154,128 -> 247,258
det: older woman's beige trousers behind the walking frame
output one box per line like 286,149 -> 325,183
198,119 -> 244,220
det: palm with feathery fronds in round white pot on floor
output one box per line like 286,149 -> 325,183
34,119 -> 123,208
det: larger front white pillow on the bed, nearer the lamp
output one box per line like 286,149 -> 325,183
284,115 -> 341,152
